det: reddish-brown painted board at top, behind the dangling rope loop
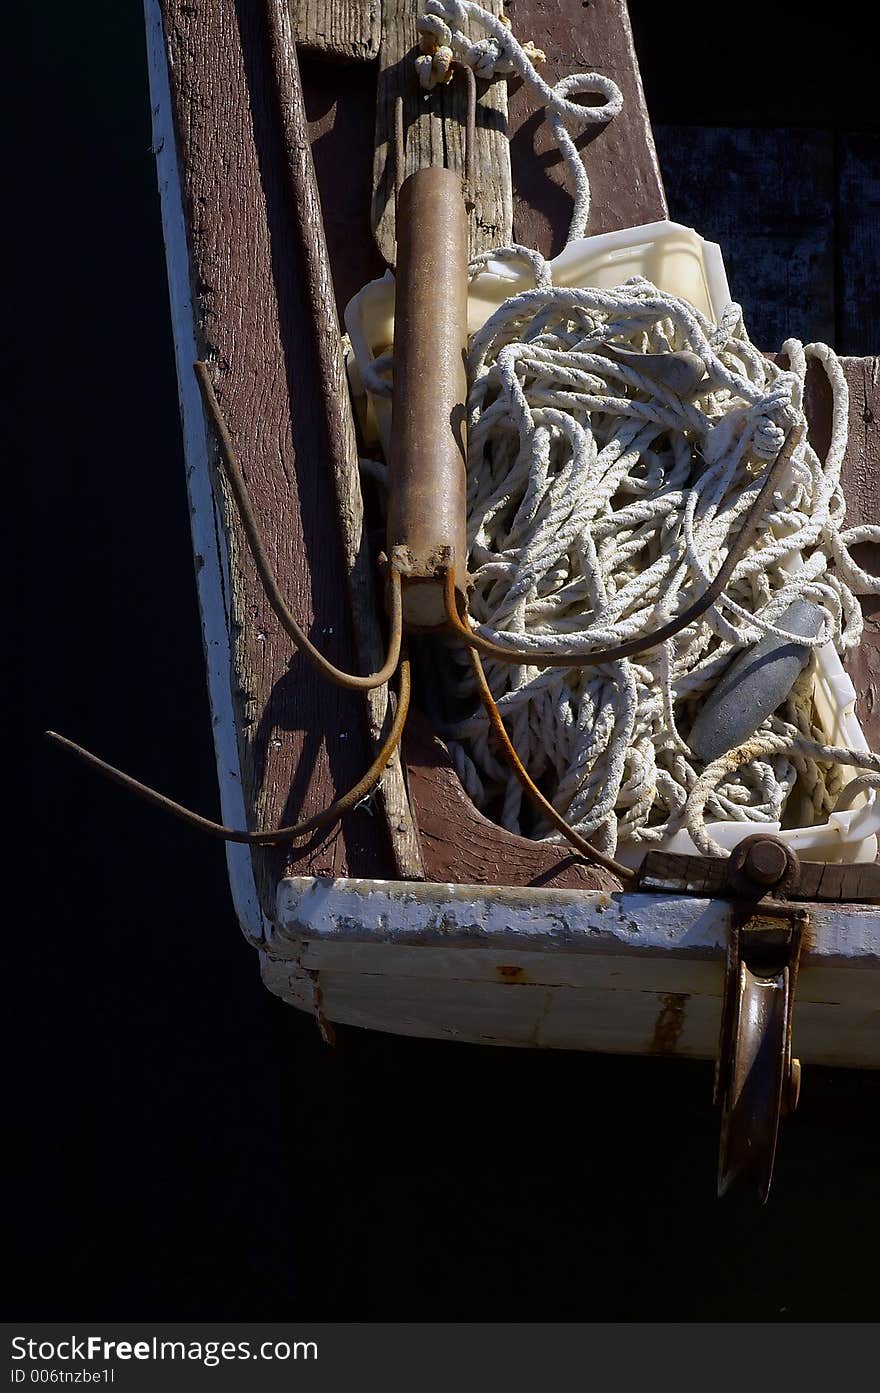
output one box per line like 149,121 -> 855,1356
507,0 -> 667,256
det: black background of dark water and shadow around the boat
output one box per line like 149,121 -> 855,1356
3,0 -> 880,1321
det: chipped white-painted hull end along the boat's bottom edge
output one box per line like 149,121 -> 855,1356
260,878 -> 880,1067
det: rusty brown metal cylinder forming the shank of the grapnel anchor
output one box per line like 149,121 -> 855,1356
387,167 -> 468,628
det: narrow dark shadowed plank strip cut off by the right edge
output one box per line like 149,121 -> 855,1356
837,131 -> 880,354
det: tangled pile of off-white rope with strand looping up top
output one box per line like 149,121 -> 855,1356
368,0 -> 880,855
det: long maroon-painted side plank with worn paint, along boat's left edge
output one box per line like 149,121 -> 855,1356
162,0 -> 403,905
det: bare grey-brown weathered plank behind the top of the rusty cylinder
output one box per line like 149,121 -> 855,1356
372,0 -> 512,266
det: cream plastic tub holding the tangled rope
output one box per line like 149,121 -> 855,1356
345,221 -> 880,865
